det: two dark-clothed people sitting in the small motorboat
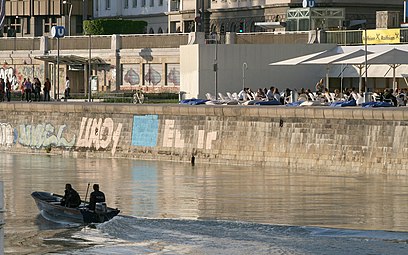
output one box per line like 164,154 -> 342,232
61,183 -> 105,210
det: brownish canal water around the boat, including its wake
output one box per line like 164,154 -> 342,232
0,152 -> 408,255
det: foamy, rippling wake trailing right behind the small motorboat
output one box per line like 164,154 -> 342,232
54,216 -> 408,255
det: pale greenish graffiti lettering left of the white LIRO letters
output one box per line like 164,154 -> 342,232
18,124 -> 75,148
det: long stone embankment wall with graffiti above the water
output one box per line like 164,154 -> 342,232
0,103 -> 408,175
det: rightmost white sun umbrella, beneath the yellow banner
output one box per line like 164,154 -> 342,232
334,48 -> 408,90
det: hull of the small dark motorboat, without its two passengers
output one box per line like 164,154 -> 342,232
31,191 -> 120,224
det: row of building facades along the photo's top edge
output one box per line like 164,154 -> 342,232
2,0 -> 403,37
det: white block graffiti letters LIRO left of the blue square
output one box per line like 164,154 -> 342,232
76,117 -> 122,156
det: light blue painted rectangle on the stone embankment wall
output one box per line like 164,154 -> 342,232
132,115 -> 159,147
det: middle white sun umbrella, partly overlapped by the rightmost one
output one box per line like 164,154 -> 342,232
302,49 -> 372,89
